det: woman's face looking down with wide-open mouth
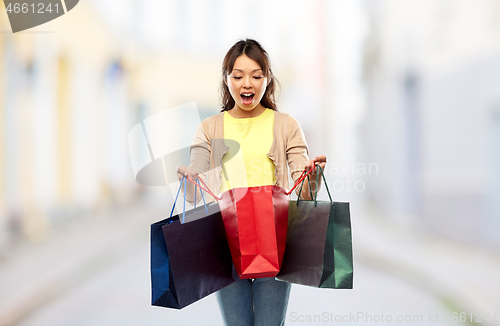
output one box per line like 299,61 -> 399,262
226,54 -> 267,111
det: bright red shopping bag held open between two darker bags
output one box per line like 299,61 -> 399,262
219,185 -> 288,279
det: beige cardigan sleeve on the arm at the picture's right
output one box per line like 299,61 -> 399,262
286,115 -> 309,195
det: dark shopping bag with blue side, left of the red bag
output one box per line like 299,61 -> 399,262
151,179 -> 234,309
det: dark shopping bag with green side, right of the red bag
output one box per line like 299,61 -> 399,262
276,165 -> 353,289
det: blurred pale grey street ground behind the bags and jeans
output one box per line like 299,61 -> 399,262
0,201 -> 500,326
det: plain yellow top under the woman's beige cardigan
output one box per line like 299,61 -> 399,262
220,109 -> 276,193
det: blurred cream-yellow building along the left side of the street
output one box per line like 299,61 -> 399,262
0,2 -> 133,246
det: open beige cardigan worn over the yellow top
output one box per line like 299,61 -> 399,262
189,109 -> 309,202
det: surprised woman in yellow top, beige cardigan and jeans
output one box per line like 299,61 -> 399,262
178,39 -> 326,326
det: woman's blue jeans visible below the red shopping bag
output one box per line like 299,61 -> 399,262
215,277 -> 291,326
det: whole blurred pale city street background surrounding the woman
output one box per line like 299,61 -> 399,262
0,0 -> 500,326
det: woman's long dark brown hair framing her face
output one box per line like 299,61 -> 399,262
220,38 -> 279,112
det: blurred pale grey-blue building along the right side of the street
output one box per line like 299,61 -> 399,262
363,0 -> 500,248
